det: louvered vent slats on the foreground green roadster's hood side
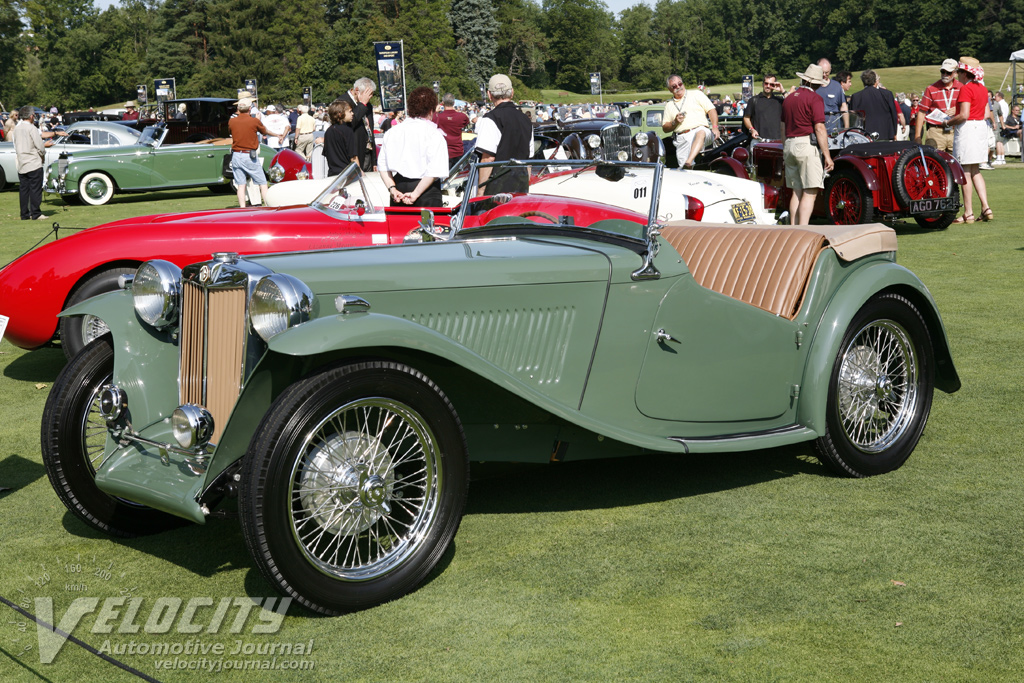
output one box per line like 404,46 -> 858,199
406,307 -> 577,385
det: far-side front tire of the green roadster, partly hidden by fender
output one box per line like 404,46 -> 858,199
40,339 -> 184,538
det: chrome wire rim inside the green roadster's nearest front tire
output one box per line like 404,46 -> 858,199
289,397 -> 442,581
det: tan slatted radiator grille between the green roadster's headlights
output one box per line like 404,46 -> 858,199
179,282 -> 247,443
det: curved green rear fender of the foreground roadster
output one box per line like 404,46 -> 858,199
797,263 -> 961,435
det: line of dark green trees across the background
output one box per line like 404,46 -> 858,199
0,0 -> 1024,110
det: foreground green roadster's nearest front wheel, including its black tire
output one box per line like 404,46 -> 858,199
239,361 -> 469,614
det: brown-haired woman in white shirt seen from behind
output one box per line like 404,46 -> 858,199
377,87 -> 449,206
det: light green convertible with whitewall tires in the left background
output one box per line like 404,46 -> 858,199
45,125 -> 274,206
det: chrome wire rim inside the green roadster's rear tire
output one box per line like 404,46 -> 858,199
839,321 -> 918,453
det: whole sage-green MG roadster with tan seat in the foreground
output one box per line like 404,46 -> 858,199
42,162 -> 959,613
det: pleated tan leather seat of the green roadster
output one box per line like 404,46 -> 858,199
662,225 -> 826,319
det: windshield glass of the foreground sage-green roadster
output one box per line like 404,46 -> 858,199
452,161 -> 662,244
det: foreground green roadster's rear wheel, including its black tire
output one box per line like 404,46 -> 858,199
816,294 -> 935,477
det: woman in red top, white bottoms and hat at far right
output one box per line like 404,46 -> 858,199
949,57 -> 993,223
